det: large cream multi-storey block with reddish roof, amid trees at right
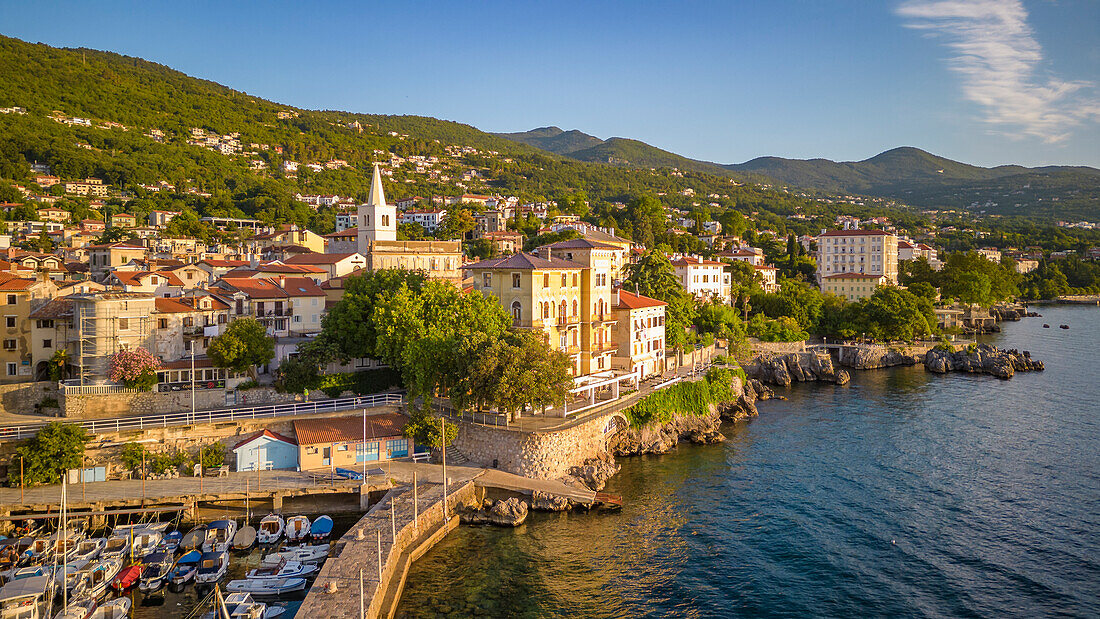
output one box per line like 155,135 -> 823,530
817,230 -> 898,292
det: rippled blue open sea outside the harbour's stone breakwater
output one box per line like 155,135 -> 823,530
399,307 -> 1100,617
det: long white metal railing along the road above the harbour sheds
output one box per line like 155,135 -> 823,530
0,385 -> 405,441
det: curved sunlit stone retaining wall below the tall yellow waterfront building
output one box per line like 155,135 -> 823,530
453,414 -> 620,479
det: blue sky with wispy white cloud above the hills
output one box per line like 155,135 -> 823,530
0,0 -> 1100,167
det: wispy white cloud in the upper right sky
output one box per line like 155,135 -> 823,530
898,0 -> 1100,142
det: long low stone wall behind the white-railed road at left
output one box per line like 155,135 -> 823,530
59,387 -> 310,419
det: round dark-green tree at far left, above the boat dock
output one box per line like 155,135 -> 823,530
8,421 -> 88,486
